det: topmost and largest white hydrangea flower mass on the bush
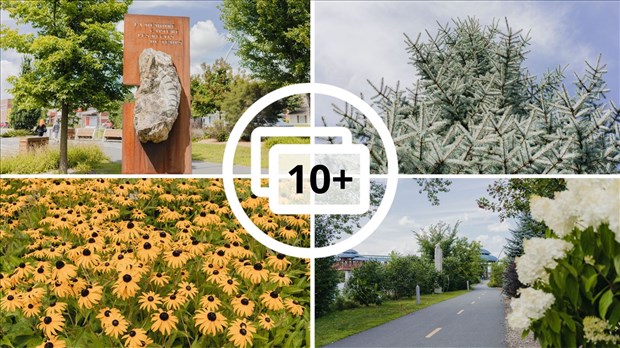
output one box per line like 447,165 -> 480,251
530,179 -> 620,243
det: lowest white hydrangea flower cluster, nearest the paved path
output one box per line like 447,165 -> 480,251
508,288 -> 555,331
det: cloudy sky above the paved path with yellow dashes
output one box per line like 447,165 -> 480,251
342,179 -> 515,256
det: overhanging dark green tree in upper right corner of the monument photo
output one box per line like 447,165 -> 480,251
220,0 -> 310,88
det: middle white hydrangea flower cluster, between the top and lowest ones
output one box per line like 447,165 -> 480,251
515,238 -> 573,284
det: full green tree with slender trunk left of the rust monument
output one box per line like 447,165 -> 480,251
0,0 -> 132,173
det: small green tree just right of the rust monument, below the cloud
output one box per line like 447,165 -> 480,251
191,58 -> 235,117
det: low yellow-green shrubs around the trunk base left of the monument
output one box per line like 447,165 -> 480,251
0,145 -> 107,174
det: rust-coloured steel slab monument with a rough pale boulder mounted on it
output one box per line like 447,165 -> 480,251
122,14 -> 192,174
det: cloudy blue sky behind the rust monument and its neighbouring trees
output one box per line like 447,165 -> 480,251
1,1 -> 239,99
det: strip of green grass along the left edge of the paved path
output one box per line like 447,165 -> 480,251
315,290 -> 467,347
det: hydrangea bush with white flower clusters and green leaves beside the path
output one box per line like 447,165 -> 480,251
508,179 -> 620,347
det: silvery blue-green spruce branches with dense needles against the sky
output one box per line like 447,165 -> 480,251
336,18 -> 620,174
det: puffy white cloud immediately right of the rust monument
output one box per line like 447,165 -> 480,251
189,20 -> 230,74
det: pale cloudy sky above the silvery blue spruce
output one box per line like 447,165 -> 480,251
313,1 -> 620,124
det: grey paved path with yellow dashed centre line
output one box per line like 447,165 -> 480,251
324,284 -> 505,348
